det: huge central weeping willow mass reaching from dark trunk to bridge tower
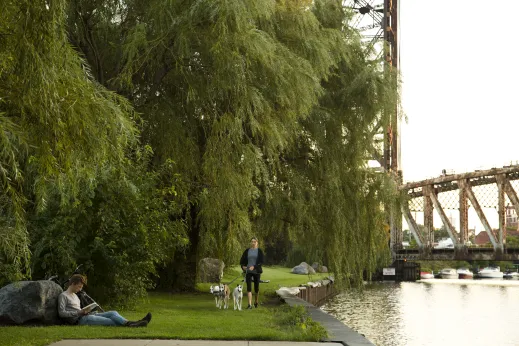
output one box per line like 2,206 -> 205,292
64,0 -> 396,284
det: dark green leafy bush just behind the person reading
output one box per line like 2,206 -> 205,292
31,152 -> 187,306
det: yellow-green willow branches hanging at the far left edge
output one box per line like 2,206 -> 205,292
0,0 -> 137,280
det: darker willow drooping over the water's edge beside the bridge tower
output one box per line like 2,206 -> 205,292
257,1 -> 398,284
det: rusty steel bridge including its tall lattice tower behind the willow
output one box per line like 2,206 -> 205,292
343,0 -> 519,260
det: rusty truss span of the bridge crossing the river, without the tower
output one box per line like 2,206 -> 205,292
391,165 -> 519,260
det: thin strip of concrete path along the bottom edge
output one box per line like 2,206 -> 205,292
50,339 -> 342,346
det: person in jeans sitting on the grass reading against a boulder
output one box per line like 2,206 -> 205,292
58,274 -> 151,327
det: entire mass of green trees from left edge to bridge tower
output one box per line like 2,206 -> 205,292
0,0 -> 398,302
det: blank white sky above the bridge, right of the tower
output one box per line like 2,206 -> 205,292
399,0 -> 519,181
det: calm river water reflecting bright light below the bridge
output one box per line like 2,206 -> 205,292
323,279 -> 519,346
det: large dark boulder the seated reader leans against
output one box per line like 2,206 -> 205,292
0,281 -> 63,324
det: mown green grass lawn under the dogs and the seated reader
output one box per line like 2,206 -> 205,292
0,267 -> 332,346
